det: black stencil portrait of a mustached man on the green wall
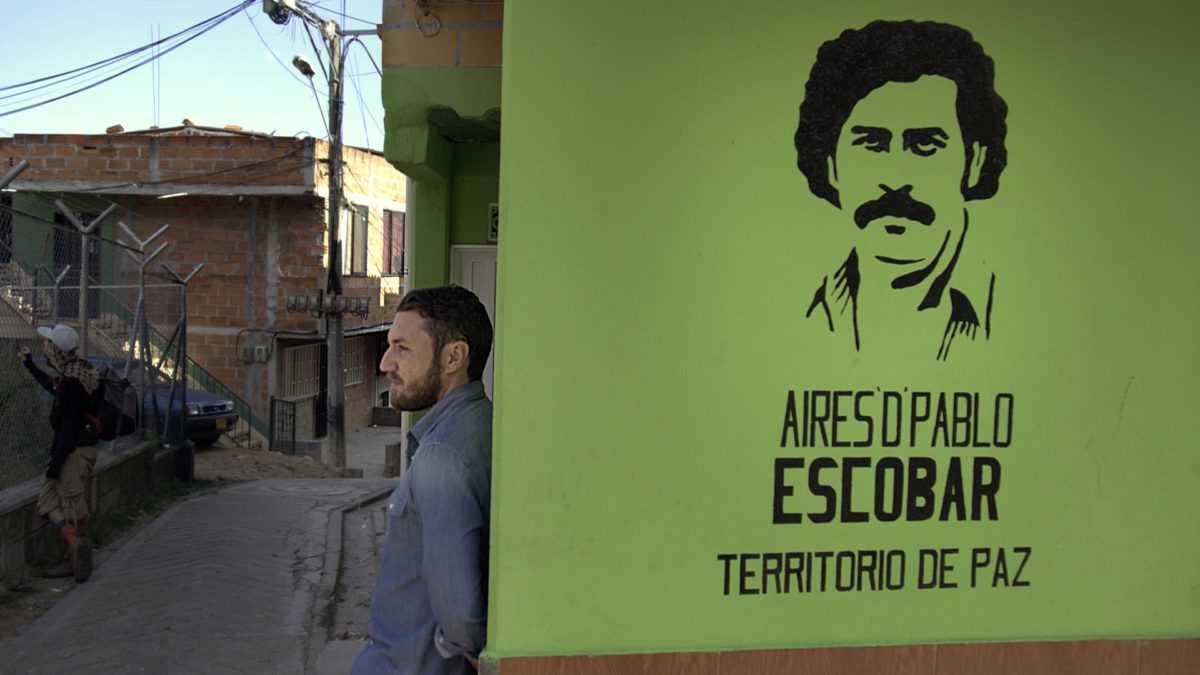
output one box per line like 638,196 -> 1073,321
794,20 -> 1008,360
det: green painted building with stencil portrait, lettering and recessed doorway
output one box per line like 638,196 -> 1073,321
384,0 -> 1200,673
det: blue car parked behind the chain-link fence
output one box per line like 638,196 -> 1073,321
28,357 -> 238,448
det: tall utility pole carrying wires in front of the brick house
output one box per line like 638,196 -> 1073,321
263,0 -> 376,468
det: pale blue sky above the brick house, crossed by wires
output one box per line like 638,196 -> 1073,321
0,0 -> 383,150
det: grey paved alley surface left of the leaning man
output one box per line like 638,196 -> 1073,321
0,479 -> 395,675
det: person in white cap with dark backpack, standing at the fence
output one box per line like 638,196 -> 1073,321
19,324 -> 100,583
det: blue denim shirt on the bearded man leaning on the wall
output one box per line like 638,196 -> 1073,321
353,382 -> 492,675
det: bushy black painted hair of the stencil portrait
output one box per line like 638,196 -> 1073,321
794,20 -> 1008,207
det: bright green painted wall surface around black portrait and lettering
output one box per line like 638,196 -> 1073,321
488,0 -> 1200,657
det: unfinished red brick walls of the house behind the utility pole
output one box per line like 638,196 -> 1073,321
0,128 -> 406,439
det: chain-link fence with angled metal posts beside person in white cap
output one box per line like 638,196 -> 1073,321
0,192 -> 180,489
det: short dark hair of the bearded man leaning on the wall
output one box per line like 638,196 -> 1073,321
396,286 -> 492,381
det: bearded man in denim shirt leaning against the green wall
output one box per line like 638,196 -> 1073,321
353,286 -> 492,675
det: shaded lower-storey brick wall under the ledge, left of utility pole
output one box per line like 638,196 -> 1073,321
113,196 -> 325,419
